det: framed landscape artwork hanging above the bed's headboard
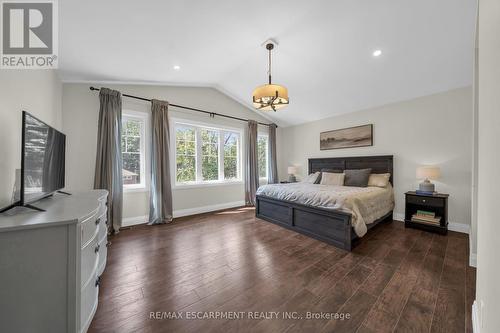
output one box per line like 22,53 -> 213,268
319,124 -> 373,150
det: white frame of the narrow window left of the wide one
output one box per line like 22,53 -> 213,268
120,109 -> 149,192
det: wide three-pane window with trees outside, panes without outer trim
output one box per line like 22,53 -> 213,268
175,122 -> 241,185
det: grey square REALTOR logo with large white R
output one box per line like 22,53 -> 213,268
0,0 -> 57,69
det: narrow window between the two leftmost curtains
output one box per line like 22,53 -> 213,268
121,111 -> 147,189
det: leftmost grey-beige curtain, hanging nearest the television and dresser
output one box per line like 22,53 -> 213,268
94,88 -> 123,233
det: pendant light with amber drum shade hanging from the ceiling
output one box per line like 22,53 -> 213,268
253,40 -> 289,112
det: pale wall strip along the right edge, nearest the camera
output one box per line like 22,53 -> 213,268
475,0 -> 500,333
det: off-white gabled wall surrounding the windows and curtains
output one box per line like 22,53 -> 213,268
63,83 -> 270,219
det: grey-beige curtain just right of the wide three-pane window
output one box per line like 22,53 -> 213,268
245,120 -> 259,206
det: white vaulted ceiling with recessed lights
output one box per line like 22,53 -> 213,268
59,0 -> 476,126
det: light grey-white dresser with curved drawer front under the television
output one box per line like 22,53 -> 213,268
0,190 -> 108,333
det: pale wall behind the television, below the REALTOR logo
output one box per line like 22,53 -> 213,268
0,70 -> 62,207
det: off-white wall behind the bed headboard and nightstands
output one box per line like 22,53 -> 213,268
278,87 -> 472,230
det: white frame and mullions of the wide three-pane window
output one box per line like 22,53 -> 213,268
171,118 -> 244,189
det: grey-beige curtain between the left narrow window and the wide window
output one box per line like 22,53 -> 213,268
149,99 -> 173,224
